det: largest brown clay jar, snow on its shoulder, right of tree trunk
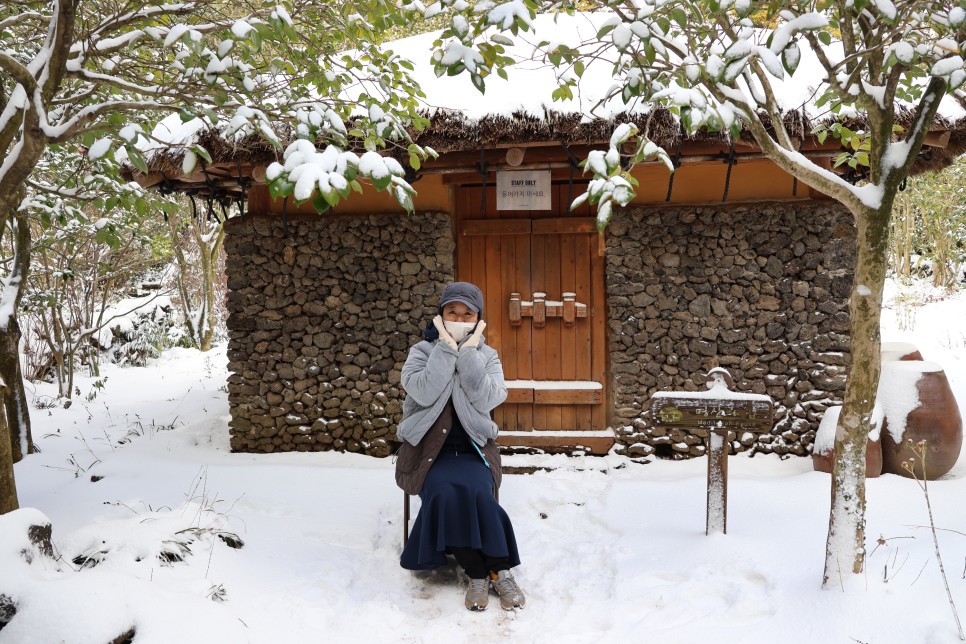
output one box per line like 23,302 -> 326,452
880,362 -> 963,480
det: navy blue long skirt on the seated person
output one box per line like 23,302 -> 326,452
399,451 -> 520,570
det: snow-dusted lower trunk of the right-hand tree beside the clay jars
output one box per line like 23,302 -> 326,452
822,200 -> 892,587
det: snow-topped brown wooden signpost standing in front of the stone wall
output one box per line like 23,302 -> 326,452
651,367 -> 774,534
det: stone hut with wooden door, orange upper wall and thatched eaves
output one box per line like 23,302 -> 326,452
138,27 -> 966,458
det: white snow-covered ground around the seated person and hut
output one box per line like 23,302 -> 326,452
0,284 -> 966,644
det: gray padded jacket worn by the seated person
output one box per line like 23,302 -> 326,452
396,338 -> 507,447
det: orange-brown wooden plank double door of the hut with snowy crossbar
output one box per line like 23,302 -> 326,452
457,186 -> 607,446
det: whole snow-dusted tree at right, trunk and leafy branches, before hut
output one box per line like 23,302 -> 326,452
420,0 -> 966,585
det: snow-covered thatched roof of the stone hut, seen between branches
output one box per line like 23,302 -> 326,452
134,13 -> 966,191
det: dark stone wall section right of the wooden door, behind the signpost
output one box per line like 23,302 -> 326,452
606,201 -> 855,458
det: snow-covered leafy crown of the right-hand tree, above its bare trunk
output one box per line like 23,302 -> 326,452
420,0 -> 966,214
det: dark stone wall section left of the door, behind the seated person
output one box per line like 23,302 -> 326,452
225,213 -> 454,456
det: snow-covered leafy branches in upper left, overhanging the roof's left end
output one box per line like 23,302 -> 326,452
0,0 -> 425,231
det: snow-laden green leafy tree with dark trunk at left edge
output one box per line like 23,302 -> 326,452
0,0 -> 434,513
